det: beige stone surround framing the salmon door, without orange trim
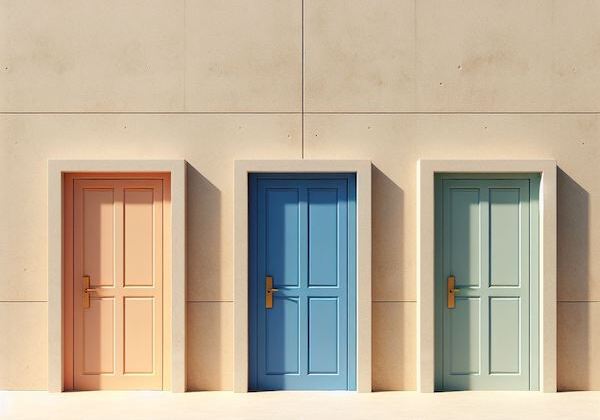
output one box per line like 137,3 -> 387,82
48,160 -> 186,392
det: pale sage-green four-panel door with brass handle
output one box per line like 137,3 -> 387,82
436,176 -> 539,390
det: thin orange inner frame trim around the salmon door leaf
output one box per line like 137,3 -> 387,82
62,172 -> 172,390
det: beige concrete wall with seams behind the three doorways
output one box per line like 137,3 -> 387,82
0,0 -> 600,389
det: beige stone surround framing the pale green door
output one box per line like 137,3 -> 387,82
417,160 -> 556,392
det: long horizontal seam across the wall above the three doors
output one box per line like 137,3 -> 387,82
0,111 -> 600,115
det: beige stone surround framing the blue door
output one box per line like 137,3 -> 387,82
233,160 -> 371,392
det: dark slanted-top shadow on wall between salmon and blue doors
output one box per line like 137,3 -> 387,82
186,163 -> 228,391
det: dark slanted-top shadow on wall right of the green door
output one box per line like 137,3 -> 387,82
557,168 -> 590,391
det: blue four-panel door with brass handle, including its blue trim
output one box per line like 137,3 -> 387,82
249,174 -> 356,390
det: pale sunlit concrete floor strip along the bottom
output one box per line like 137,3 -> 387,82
0,391 -> 600,420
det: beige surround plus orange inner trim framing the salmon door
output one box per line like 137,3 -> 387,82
48,160 -> 186,392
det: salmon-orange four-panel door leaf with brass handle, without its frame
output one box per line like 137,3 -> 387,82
72,179 -> 163,390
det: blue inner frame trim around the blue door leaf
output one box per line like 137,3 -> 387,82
248,173 -> 357,390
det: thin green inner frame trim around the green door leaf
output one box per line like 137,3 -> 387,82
434,173 -> 541,391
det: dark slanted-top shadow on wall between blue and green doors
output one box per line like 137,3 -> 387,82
372,165 -> 416,391
